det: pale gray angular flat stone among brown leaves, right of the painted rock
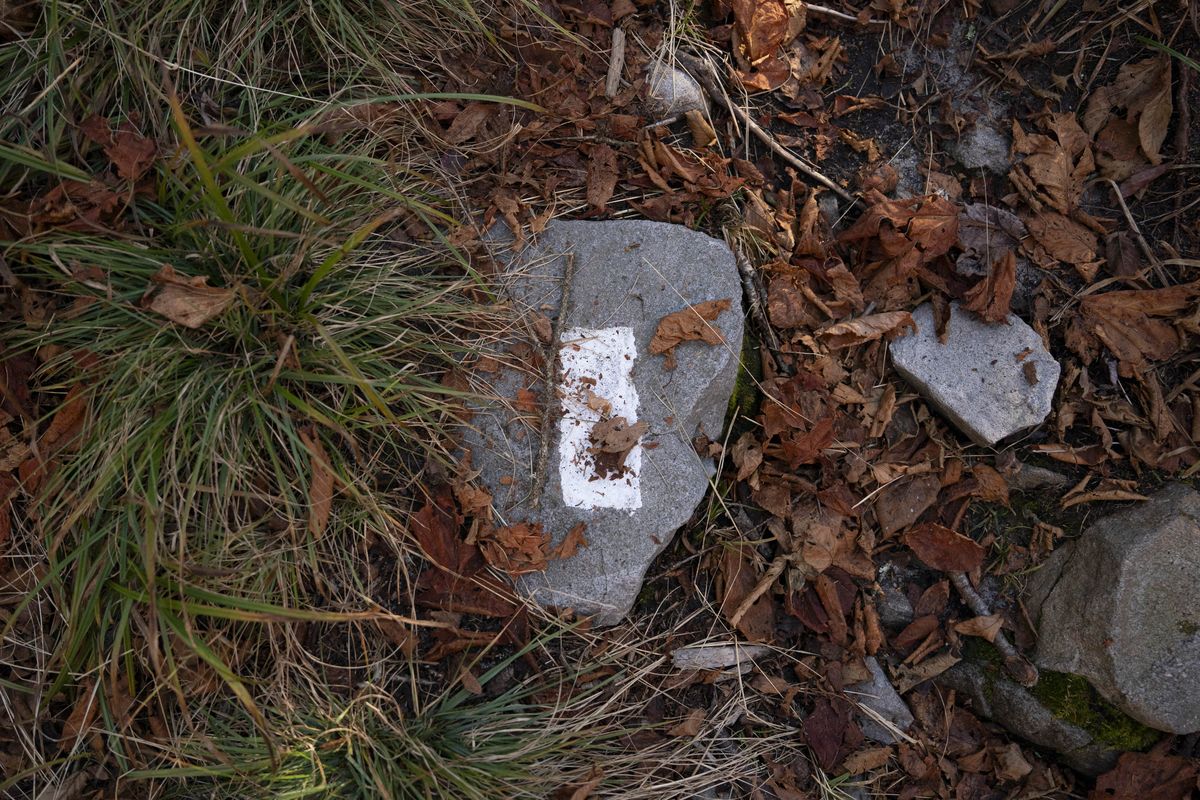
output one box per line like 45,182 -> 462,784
889,302 -> 1060,445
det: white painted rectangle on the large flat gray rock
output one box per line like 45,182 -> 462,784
558,327 -> 642,510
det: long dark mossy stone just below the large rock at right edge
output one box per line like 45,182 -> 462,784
936,661 -> 1121,776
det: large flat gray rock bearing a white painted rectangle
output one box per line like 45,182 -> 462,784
466,221 -> 743,625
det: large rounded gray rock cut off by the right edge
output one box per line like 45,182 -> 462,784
1030,485 -> 1200,734
